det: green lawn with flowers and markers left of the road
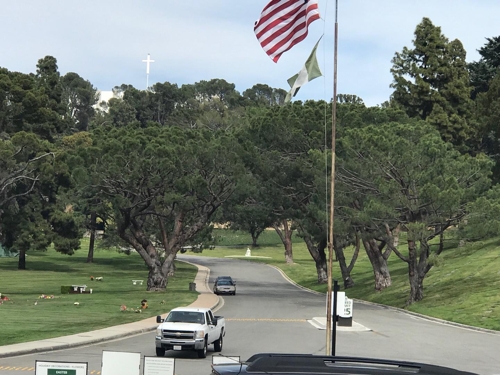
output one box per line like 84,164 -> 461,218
0,244 -> 198,345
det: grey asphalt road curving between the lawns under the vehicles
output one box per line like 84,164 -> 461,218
0,256 -> 500,375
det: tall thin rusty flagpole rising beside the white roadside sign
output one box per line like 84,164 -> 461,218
326,0 -> 338,355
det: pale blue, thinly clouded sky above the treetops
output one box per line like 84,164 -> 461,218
0,0 -> 500,106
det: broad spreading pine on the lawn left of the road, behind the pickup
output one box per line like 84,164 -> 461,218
73,126 -> 244,291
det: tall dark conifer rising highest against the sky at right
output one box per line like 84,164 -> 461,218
391,18 -> 475,151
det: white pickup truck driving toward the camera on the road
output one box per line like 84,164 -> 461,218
155,307 -> 226,358
